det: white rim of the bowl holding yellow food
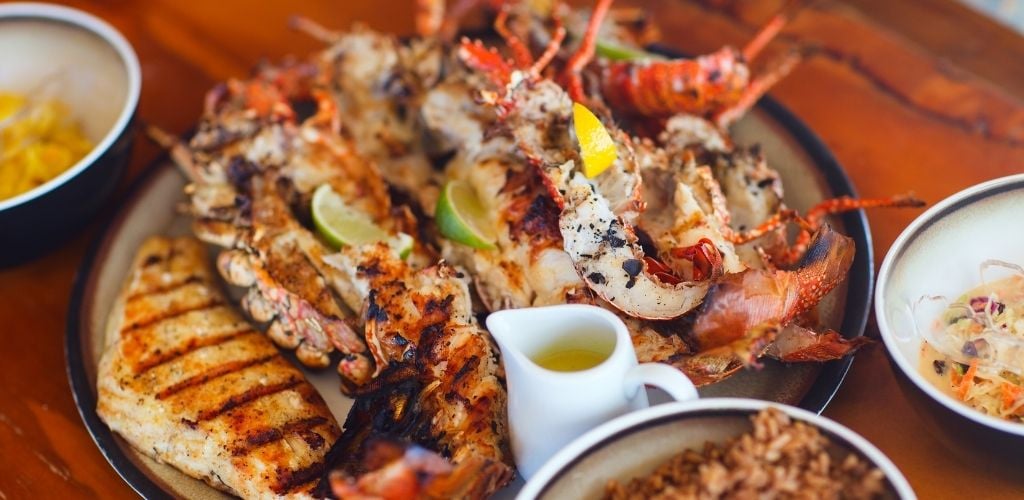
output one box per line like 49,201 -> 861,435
0,2 -> 142,210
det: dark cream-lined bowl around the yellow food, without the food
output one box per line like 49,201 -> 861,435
0,3 -> 141,266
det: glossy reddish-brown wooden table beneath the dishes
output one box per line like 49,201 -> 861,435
0,0 -> 1024,499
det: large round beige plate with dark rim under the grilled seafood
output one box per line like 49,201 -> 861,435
66,92 -> 873,498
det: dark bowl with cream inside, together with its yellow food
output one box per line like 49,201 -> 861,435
0,3 -> 141,265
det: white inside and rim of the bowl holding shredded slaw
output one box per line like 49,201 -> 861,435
874,174 -> 1024,438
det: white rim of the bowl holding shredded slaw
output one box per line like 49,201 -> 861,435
874,174 -> 1024,435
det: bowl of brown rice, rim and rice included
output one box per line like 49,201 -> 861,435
517,398 -> 915,500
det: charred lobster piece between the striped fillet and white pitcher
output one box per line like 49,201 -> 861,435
328,241 -> 512,498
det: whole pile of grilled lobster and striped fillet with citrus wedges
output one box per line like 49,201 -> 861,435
83,0 -> 920,498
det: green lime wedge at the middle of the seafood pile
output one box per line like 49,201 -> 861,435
434,180 -> 496,250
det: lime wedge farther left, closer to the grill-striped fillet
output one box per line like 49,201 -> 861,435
312,184 -> 413,258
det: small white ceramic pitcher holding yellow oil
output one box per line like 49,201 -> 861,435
487,304 -> 697,480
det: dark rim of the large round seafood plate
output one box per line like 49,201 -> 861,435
65,68 -> 874,499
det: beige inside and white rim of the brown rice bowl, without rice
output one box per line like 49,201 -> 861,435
516,398 -> 916,500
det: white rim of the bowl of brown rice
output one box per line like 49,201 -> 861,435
516,398 -> 916,500
